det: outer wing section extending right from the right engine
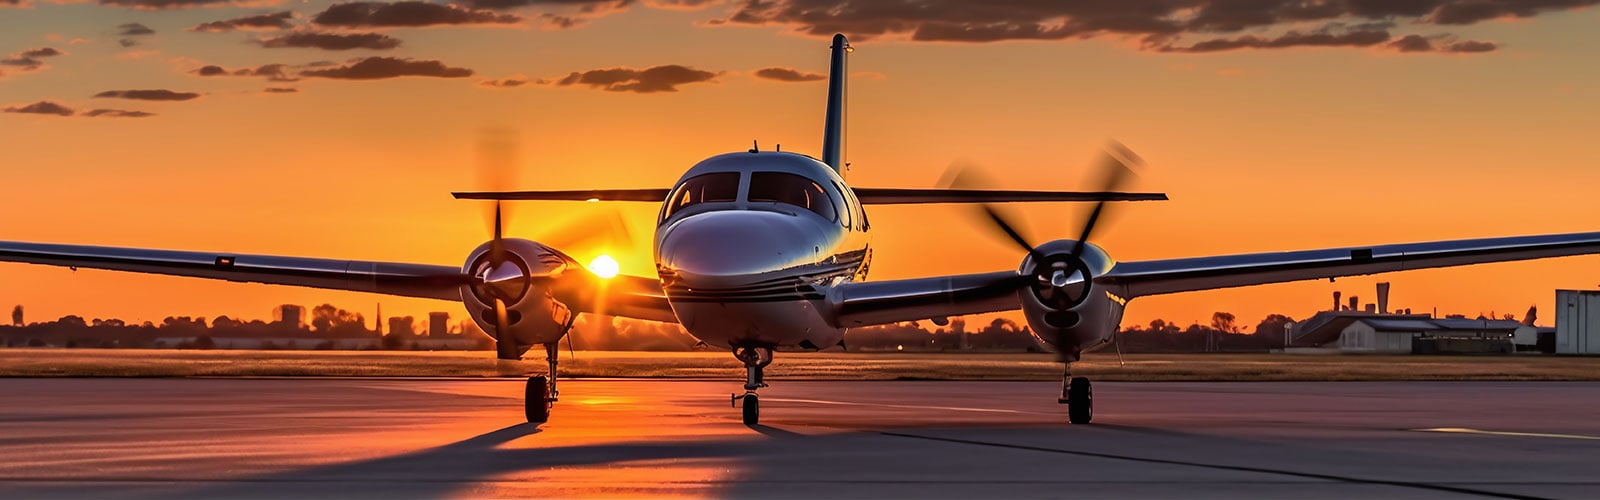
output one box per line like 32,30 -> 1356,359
1094,232 -> 1600,298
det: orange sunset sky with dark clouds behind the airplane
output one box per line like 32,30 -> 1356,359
0,0 -> 1600,331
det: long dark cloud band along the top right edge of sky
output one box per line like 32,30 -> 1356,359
709,0 -> 1600,51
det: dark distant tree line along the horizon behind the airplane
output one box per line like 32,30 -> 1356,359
0,304 -> 1294,353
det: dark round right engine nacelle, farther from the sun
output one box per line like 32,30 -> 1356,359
1018,239 -> 1126,359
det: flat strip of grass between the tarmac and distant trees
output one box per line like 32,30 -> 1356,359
0,349 -> 1600,381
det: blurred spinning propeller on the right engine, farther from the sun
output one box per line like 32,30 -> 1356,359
941,141 -> 1144,361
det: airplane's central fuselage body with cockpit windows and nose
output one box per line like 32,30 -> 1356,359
654,152 -> 872,348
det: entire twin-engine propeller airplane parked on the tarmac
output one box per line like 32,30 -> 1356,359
0,34 -> 1600,425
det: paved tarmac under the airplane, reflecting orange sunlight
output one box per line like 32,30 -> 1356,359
0,378 -> 1600,498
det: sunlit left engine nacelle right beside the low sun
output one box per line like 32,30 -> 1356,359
461,239 -> 582,354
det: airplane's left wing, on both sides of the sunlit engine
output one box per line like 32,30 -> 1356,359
0,242 -> 677,322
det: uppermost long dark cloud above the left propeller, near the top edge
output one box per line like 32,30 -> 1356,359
310,2 -> 522,27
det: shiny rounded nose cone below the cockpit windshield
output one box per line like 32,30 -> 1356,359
659,210 -> 822,288
